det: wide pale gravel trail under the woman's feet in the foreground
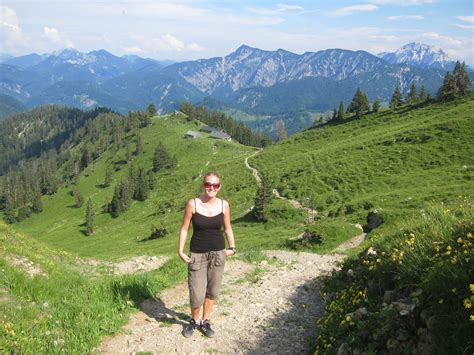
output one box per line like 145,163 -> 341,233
99,251 -> 350,354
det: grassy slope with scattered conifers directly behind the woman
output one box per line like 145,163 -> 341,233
15,116 -> 310,259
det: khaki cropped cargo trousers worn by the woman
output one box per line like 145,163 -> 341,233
188,249 -> 227,308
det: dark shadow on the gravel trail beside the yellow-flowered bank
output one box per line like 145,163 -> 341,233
234,277 -> 330,354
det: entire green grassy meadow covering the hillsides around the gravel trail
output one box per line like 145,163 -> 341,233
0,94 -> 474,353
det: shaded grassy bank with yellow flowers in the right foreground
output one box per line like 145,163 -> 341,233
315,201 -> 474,354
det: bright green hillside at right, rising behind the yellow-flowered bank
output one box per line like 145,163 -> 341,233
252,95 -> 474,221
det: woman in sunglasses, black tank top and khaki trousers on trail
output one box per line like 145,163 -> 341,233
178,173 -> 235,337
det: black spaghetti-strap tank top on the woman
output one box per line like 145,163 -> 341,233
189,199 -> 225,253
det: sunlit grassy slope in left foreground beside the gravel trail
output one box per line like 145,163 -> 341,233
0,222 -> 186,354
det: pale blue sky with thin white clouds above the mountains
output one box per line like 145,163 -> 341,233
0,0 -> 474,66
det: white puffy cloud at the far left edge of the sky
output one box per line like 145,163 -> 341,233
0,6 -> 25,53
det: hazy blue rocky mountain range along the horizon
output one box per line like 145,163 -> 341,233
0,43 -> 466,130
